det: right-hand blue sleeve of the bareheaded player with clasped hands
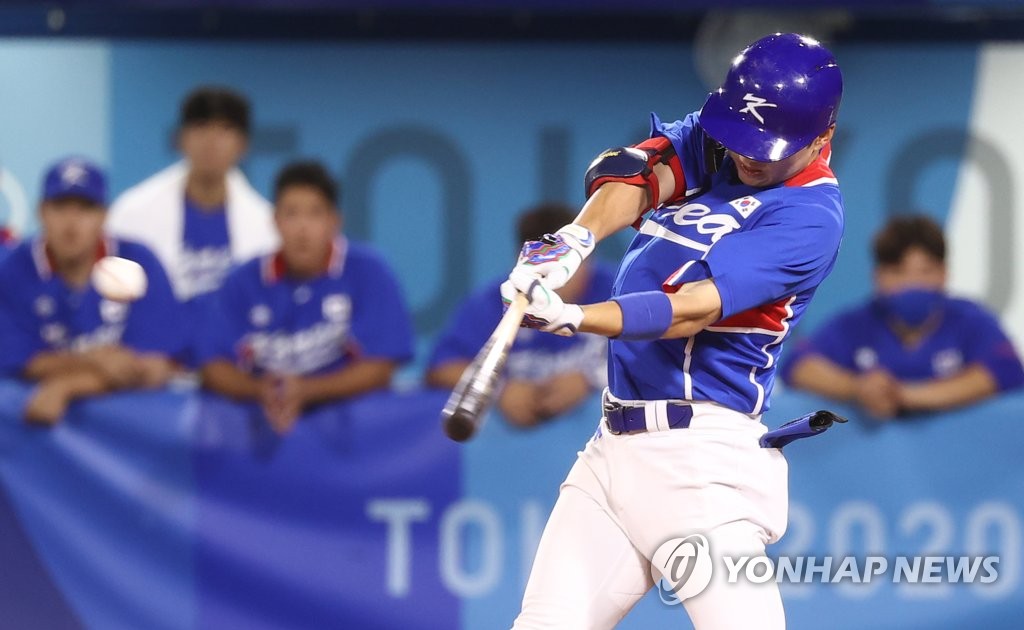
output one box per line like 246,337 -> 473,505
352,258 -> 413,363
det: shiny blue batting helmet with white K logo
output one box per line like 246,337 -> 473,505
700,33 -> 843,162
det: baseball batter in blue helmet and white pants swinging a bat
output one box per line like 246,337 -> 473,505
502,34 -> 844,630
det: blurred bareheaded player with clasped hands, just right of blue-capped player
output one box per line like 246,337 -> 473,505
198,162 -> 413,432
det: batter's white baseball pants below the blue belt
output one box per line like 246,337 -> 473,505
514,403 -> 788,630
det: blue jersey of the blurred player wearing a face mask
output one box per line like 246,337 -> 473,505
782,296 -> 1024,390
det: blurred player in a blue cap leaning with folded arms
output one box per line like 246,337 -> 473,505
0,158 -> 182,423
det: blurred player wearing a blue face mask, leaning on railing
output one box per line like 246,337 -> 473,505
782,216 -> 1024,418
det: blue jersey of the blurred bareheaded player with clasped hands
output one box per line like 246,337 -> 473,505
197,239 -> 413,375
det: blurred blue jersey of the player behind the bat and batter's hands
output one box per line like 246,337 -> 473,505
428,263 -> 613,386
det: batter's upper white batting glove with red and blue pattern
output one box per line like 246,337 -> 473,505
509,223 -> 597,290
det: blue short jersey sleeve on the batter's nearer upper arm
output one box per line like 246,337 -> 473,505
705,205 -> 843,319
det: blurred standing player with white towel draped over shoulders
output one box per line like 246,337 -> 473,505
108,87 -> 278,313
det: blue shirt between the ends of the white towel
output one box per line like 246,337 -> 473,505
180,197 -> 231,298
